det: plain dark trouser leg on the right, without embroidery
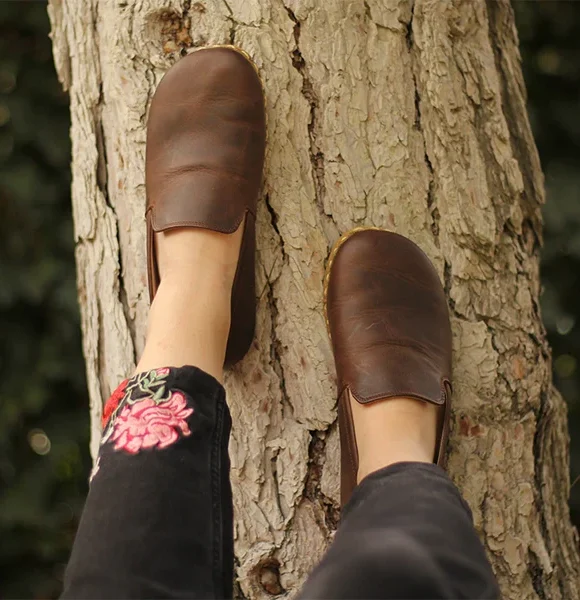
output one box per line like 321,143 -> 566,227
300,462 -> 500,600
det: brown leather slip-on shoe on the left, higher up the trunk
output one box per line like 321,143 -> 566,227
146,46 -> 266,366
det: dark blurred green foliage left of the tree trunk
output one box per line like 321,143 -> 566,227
0,1 -> 90,598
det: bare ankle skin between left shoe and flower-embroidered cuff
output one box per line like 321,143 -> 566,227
136,223 -> 243,381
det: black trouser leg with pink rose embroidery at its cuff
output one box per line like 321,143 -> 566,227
63,366 -> 233,599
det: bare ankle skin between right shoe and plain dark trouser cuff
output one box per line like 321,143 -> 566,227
350,395 -> 438,482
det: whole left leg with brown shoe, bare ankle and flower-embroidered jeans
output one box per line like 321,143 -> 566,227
63,48 -> 265,598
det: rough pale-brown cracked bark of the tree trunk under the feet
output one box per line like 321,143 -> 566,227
49,0 -> 580,600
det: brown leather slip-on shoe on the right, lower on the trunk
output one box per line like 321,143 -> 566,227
324,228 -> 451,505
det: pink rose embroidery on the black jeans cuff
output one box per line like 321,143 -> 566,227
111,392 -> 193,454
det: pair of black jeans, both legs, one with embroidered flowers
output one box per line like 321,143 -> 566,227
63,367 -> 499,599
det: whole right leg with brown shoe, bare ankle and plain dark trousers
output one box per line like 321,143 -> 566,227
301,230 -> 499,599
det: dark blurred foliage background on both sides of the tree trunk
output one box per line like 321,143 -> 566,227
0,0 -> 580,598
